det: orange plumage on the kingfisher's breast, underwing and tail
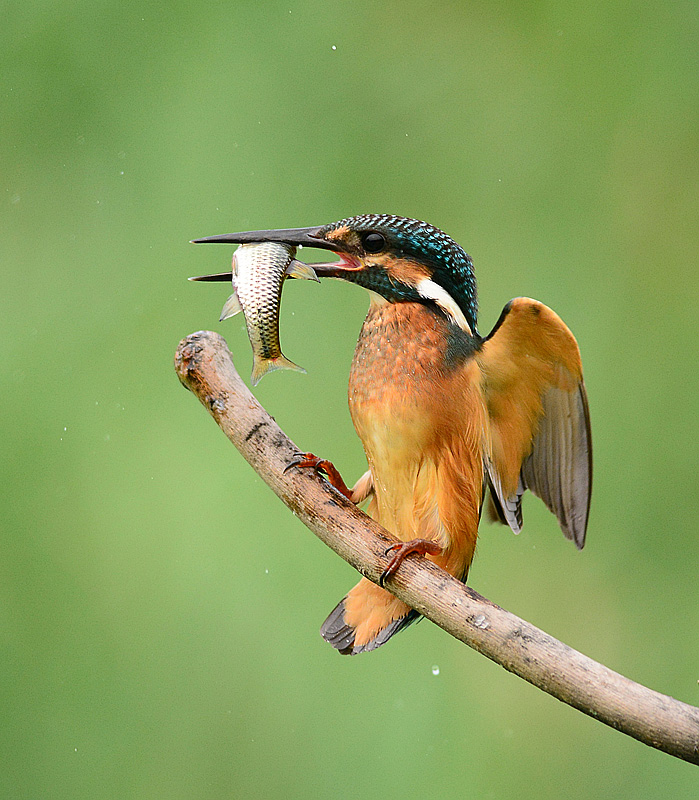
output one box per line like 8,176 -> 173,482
323,290 -> 589,653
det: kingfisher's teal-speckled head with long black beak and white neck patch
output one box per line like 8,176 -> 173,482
195,214 -> 477,335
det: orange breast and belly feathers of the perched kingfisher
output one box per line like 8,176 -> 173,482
349,303 -> 487,578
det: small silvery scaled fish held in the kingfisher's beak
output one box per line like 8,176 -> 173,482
220,242 -> 320,386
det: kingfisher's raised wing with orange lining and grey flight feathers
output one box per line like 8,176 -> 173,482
478,297 -> 592,548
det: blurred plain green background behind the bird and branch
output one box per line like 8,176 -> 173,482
0,0 -> 699,800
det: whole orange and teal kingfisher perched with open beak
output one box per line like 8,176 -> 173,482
194,214 -> 592,655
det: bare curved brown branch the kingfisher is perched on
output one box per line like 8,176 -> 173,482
175,331 -> 699,764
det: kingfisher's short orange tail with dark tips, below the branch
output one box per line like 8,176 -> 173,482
320,578 -> 420,656
